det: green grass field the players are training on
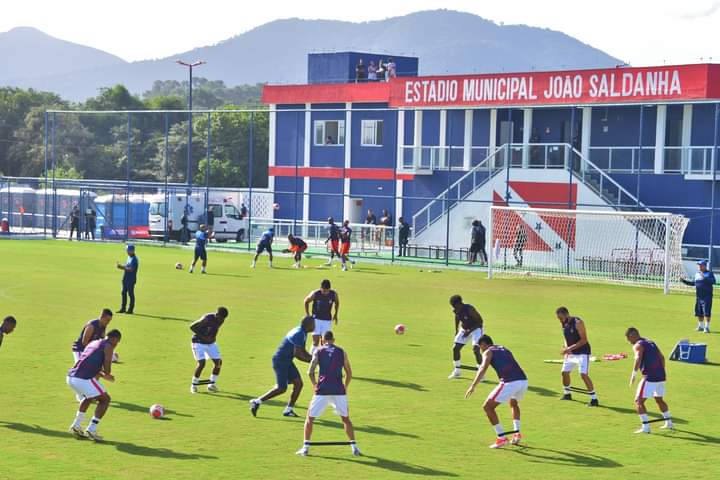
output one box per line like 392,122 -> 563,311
0,241 -> 720,480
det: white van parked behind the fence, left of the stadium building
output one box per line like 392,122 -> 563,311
148,193 -> 247,242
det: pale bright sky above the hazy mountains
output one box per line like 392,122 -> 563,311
0,0 -> 720,66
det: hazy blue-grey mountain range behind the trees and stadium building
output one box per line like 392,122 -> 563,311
0,10 -> 619,100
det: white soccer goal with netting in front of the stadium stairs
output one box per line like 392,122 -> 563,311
488,206 -> 688,293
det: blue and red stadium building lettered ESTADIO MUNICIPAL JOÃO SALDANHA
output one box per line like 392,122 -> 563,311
263,52 -> 720,257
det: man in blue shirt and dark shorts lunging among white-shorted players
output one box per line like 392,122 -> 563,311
250,316 -> 315,417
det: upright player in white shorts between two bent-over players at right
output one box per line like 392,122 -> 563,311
555,307 -> 599,407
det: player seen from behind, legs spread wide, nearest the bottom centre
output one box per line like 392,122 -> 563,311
297,330 -> 360,457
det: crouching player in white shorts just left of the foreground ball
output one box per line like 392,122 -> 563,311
67,330 -> 122,442
